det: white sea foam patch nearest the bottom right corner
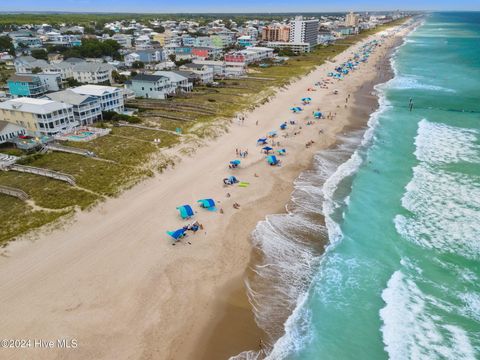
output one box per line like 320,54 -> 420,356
380,271 -> 475,360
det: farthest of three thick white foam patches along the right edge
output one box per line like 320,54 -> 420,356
415,119 -> 480,164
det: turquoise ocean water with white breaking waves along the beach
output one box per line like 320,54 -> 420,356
249,13 -> 480,360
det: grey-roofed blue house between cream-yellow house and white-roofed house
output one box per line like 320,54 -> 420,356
45,89 -> 102,125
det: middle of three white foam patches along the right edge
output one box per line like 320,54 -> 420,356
394,163 -> 480,259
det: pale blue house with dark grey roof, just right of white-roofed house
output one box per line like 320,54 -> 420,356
125,74 -> 175,99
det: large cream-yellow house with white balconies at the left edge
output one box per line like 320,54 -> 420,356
0,97 -> 79,135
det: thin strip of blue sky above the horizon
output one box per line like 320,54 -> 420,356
0,0 -> 480,13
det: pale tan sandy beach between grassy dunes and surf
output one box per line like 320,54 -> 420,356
0,21 -> 407,359
